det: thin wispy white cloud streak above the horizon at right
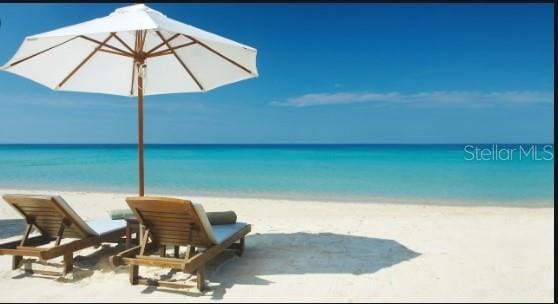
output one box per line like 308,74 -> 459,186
269,91 -> 554,108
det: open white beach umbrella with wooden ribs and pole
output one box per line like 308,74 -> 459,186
2,4 -> 258,196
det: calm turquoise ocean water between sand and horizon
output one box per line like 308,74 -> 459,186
0,145 -> 554,206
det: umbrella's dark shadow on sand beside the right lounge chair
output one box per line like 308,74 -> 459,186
143,232 -> 420,300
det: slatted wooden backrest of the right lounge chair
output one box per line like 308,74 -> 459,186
126,196 -> 216,247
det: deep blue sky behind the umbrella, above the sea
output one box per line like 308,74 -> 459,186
0,4 -> 554,143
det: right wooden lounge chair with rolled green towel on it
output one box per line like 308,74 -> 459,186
110,197 -> 251,291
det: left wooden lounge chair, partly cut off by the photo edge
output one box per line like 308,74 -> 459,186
0,194 -> 126,276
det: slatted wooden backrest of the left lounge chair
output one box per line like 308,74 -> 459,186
2,194 -> 97,238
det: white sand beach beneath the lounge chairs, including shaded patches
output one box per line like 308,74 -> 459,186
0,190 -> 554,302
